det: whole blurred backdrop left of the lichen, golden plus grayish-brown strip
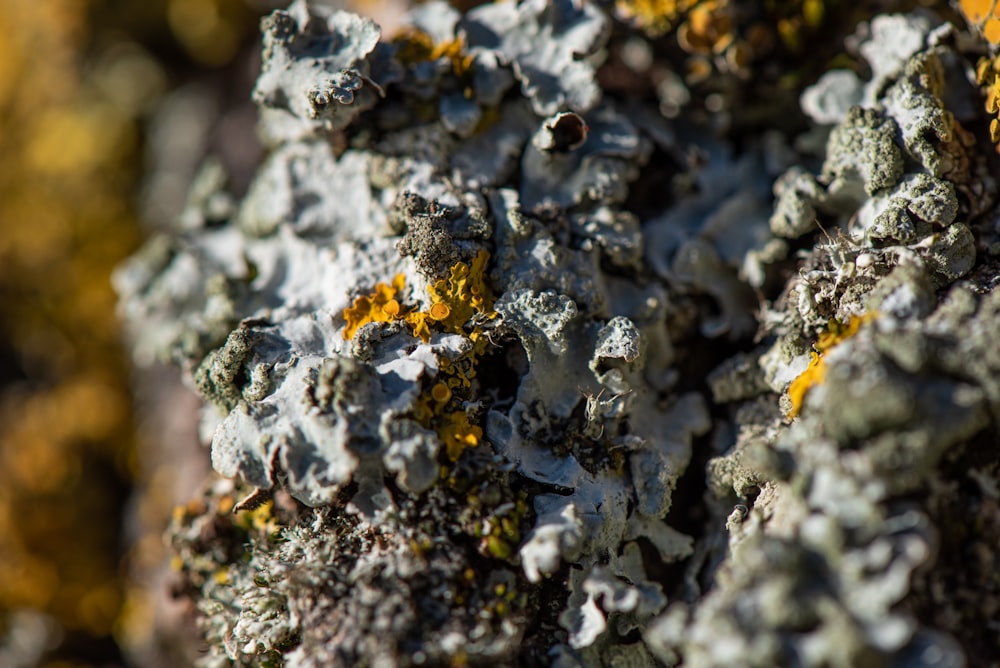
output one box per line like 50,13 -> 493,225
0,0 -> 275,668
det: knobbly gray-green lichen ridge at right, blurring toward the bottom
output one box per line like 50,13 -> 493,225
646,11 -> 996,666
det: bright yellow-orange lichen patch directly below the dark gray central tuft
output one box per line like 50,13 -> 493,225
406,251 -> 493,342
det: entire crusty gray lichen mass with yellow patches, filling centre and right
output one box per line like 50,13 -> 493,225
116,0 -> 1000,666
